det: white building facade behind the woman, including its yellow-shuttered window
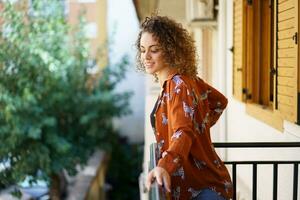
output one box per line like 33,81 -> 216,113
136,0 -> 300,200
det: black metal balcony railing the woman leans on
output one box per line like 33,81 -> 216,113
149,142 -> 300,200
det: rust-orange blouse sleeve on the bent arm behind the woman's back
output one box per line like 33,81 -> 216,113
205,83 -> 228,127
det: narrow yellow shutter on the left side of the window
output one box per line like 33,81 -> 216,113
233,0 -> 245,101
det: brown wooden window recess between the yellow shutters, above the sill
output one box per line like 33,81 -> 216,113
243,0 -> 276,107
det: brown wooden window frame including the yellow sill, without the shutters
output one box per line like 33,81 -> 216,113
243,0 -> 284,132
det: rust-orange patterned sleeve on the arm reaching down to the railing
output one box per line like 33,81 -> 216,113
158,83 -> 194,175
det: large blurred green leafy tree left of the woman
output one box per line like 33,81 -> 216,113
0,1 -> 130,199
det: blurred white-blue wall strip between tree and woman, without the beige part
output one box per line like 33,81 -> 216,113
107,0 -> 145,143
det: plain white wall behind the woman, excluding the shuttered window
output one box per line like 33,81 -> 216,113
138,0 -> 300,200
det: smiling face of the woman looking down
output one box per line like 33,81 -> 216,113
140,32 -> 166,74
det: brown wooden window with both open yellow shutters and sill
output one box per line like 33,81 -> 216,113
232,0 -> 300,129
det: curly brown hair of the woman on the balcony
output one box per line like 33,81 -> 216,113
135,15 -> 197,77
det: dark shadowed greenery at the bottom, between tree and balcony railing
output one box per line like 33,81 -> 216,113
106,134 -> 144,200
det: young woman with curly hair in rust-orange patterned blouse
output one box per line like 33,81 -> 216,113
136,15 -> 232,200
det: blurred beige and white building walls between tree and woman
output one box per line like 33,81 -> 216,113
69,0 -> 145,143
